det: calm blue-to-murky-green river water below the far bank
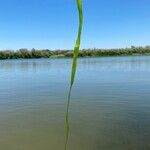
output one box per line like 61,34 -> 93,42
0,56 -> 150,150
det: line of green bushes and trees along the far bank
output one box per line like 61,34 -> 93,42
0,46 -> 150,59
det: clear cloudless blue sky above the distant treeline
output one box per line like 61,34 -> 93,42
0,0 -> 150,50
